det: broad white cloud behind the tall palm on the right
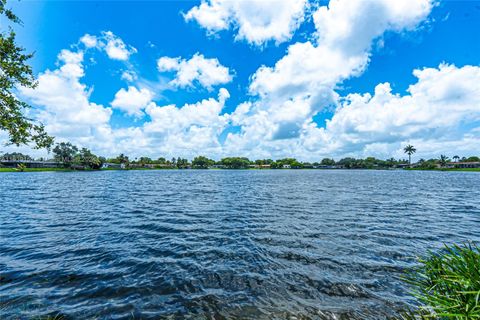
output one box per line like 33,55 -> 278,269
303,65 -> 480,156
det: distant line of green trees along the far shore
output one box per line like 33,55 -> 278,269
0,142 -> 480,170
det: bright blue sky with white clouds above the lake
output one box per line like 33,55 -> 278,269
0,0 -> 480,161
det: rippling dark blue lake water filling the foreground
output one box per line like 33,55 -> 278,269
0,170 -> 480,319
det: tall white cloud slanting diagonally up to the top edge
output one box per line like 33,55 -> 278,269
223,0 -> 433,159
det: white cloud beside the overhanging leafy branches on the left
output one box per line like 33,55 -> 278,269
20,50 -> 112,148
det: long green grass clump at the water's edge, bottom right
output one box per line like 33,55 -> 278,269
402,243 -> 480,320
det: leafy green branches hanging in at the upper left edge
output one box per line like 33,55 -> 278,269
0,0 -> 53,149
